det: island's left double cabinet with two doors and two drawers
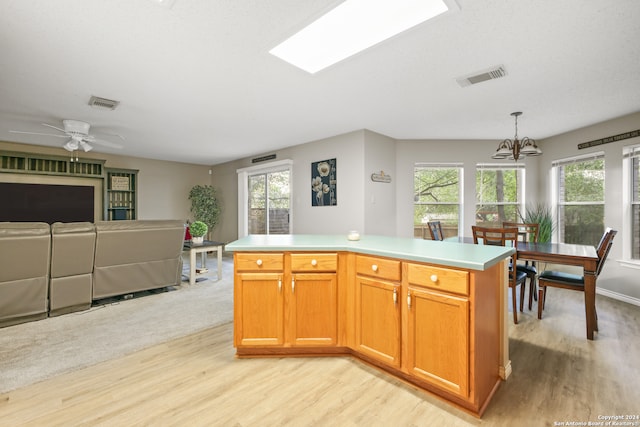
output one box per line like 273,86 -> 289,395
234,253 -> 338,347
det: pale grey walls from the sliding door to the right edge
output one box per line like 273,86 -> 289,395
213,113 -> 640,305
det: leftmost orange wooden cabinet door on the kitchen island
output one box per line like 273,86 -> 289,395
234,273 -> 284,346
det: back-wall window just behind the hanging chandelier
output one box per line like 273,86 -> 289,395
476,164 -> 525,227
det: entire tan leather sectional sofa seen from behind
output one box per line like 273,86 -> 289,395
0,220 -> 185,327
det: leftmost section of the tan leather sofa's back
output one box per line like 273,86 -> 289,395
0,222 -> 51,327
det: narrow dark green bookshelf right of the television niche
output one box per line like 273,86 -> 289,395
104,168 -> 138,221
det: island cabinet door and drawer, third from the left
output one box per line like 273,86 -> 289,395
354,255 -> 401,368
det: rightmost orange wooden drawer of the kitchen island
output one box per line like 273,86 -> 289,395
407,264 -> 469,295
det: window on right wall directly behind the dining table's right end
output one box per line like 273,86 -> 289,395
552,153 -> 605,246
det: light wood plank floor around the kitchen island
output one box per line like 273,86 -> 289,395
0,289 -> 640,427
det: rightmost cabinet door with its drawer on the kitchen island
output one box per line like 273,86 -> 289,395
405,263 -> 471,399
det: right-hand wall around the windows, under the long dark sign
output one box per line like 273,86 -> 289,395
539,113 -> 640,305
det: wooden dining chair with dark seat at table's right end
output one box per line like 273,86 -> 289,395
538,227 -> 618,331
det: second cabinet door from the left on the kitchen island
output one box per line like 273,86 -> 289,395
287,273 -> 338,346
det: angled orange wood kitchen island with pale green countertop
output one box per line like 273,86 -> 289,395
226,235 -> 513,416
